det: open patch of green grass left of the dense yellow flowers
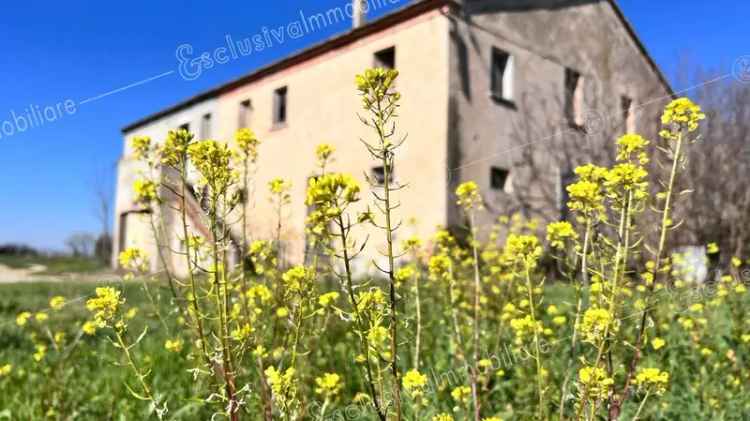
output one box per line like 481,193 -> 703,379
0,282 -> 210,420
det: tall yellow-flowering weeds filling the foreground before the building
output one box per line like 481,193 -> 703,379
0,69 -> 750,421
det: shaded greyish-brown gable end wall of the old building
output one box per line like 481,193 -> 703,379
449,0 -> 670,230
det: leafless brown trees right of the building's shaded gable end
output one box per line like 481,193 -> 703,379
678,70 -> 750,261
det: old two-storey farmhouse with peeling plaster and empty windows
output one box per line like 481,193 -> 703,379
113,0 -> 671,272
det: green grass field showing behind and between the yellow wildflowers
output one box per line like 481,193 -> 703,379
0,281 -> 750,421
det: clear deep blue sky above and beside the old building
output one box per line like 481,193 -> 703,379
0,0 -> 750,249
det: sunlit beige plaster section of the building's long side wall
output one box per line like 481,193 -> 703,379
219,11 -> 448,272
